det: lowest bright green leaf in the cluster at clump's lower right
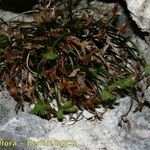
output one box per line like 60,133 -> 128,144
101,89 -> 117,101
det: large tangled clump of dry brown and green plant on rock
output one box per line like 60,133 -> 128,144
0,1 -> 149,121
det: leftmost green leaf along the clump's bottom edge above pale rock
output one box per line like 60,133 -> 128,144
32,100 -> 50,116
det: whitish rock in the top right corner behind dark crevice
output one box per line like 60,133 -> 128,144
126,0 -> 150,33
